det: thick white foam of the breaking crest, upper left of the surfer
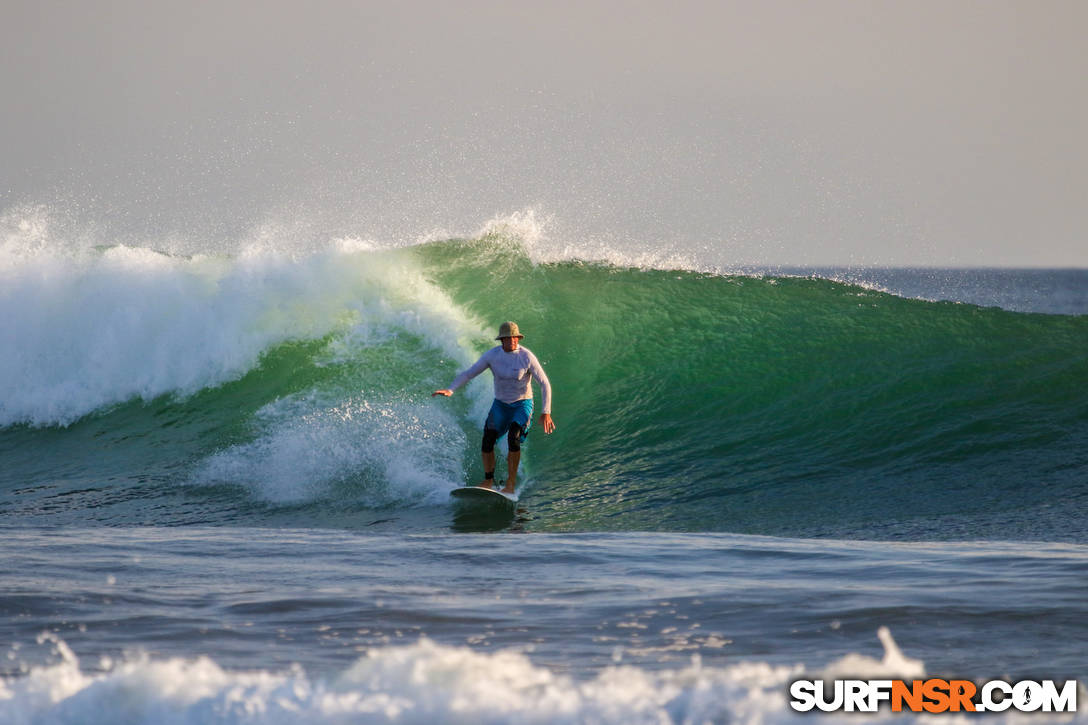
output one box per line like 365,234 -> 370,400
0,209 -> 480,427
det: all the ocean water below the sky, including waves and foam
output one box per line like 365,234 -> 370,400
0,212 -> 1088,723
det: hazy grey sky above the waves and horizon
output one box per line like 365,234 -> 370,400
0,0 -> 1088,267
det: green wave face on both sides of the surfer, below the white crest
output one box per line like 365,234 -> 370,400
0,236 -> 1088,539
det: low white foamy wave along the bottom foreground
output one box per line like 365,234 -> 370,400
0,631 -> 987,725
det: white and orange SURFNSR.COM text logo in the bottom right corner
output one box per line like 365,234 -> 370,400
790,678 -> 1077,713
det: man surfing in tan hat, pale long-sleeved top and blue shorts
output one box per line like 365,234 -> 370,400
431,322 -> 555,493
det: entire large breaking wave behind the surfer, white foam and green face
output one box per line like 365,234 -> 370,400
0,212 -> 1088,538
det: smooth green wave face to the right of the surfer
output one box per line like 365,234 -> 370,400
413,237 -> 1088,537
